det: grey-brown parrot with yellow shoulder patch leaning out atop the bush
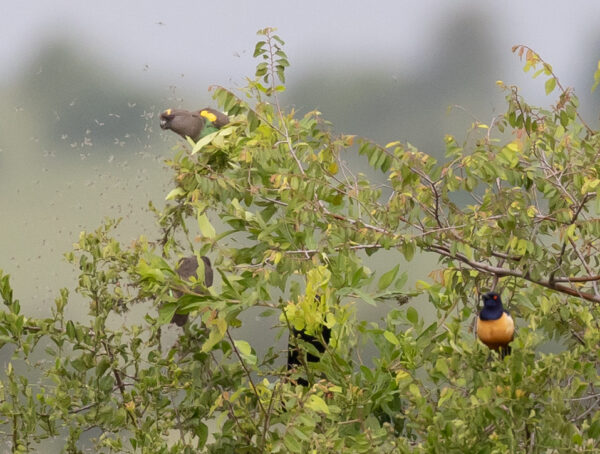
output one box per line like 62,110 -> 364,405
160,107 -> 229,142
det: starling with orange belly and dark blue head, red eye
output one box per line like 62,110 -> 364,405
477,292 -> 515,357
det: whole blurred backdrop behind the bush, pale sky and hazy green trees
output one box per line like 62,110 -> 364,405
0,0 -> 600,362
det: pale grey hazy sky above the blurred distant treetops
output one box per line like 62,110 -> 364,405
0,0 -> 600,95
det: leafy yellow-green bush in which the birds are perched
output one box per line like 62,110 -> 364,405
0,29 -> 600,453
